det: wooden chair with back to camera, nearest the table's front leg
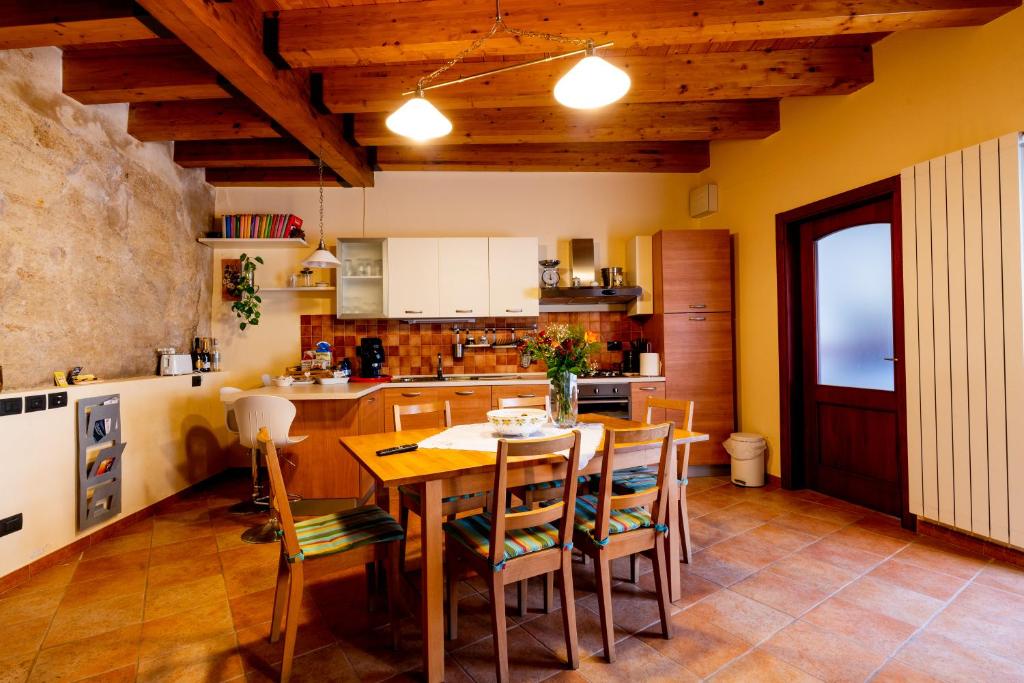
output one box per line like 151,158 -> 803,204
444,430 -> 582,682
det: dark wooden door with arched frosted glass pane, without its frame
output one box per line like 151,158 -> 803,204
800,198 -> 905,515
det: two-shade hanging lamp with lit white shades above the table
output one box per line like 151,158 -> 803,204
385,0 -> 631,142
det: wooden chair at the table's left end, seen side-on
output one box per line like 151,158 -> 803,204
258,428 -> 404,683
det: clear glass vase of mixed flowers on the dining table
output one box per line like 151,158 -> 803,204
519,323 -> 600,427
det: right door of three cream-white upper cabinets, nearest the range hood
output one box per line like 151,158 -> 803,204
487,238 -> 541,316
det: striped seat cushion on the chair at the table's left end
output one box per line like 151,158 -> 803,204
295,505 -> 402,557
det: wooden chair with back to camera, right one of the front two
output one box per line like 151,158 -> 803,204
572,422 -> 678,663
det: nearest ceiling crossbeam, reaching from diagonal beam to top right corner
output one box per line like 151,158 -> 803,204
278,0 -> 1020,67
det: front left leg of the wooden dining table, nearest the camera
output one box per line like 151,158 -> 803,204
420,479 -> 444,683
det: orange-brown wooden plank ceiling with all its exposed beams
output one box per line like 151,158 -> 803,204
0,0 -> 1021,186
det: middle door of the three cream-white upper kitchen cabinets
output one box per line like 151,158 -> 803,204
437,238 -> 490,317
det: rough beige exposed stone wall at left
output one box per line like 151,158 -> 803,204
0,48 -> 213,389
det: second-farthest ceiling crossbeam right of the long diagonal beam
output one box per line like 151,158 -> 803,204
355,99 -> 779,146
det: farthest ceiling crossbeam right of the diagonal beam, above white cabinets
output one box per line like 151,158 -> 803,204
377,142 -> 711,173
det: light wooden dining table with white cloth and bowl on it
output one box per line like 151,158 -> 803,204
339,415 -> 709,681
